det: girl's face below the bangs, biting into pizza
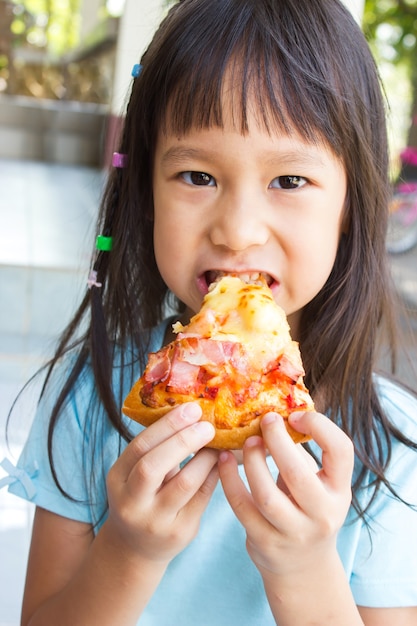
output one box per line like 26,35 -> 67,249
153,112 -> 347,337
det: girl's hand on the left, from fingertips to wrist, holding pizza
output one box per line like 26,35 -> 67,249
106,403 -> 218,564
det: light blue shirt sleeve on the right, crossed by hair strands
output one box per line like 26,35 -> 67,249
350,382 -> 417,608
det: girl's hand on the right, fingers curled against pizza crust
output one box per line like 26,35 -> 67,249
219,413 -> 354,577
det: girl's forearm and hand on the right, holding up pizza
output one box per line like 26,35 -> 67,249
219,413 -> 364,626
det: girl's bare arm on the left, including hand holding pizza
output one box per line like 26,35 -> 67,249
22,404 -> 218,626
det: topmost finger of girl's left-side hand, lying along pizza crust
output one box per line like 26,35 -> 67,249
118,402 -> 202,480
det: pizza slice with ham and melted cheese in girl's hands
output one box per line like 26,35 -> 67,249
123,275 -> 314,449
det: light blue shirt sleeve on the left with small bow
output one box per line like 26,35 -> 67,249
3,318 -> 167,529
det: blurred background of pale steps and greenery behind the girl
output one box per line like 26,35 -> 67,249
0,0 -> 417,626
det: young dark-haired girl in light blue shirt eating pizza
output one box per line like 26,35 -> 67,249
5,0 -> 417,626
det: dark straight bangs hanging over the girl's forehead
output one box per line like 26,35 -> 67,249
144,0 -> 345,154
